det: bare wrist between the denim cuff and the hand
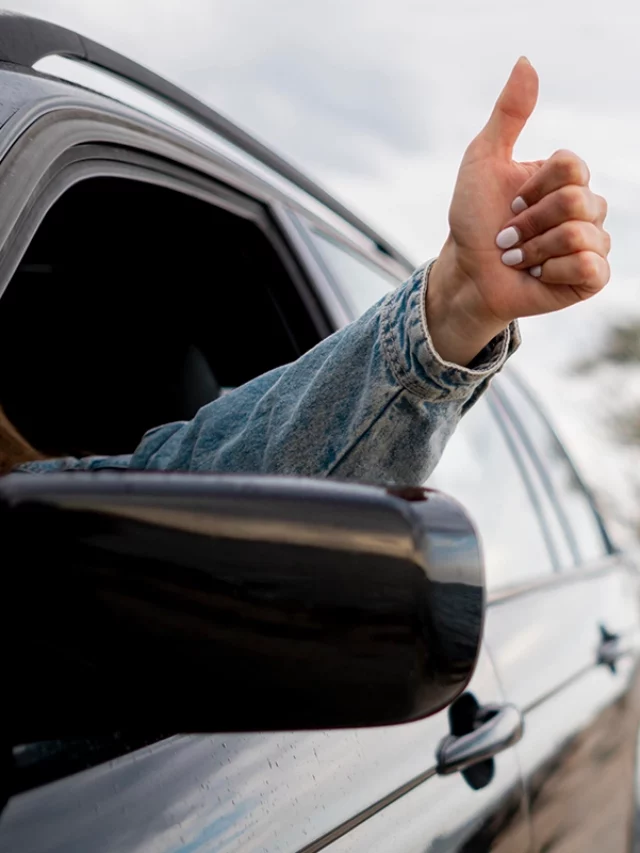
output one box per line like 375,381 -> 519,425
425,237 -> 509,367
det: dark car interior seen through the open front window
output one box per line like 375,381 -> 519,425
0,177 -> 318,456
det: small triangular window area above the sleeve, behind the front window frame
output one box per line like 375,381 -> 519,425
311,230 -> 400,316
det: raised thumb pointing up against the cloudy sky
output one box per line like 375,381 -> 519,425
480,56 -> 538,159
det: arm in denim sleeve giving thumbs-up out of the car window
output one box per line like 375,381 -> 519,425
10,61 -> 608,483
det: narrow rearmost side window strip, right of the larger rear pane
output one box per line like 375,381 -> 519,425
502,375 -> 607,563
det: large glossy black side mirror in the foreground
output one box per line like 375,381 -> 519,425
0,472 -> 484,743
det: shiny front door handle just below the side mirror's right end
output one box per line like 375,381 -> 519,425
436,705 -> 524,776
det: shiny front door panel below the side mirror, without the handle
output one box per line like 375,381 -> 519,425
0,655 -> 528,853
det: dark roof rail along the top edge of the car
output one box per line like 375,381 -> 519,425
0,12 -> 413,269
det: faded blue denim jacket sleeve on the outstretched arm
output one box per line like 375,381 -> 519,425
12,264 -> 520,485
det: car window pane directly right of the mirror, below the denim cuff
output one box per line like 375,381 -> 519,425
427,396 -> 554,590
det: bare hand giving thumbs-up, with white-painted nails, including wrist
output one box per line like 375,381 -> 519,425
426,58 -> 610,364
